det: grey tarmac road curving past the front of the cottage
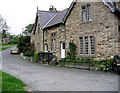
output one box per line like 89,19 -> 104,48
2,48 -> 118,91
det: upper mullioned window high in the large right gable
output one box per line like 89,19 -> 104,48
82,4 -> 92,21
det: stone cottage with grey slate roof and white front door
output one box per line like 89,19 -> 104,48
31,0 -> 120,59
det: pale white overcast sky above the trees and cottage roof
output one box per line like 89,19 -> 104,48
0,0 -> 73,35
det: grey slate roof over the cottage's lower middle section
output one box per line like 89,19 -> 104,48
38,8 -> 68,29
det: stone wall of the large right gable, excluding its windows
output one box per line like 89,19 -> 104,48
66,2 -> 120,59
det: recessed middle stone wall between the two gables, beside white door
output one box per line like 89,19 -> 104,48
44,26 -> 65,58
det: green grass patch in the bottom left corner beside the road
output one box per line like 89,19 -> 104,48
0,71 -> 26,93
